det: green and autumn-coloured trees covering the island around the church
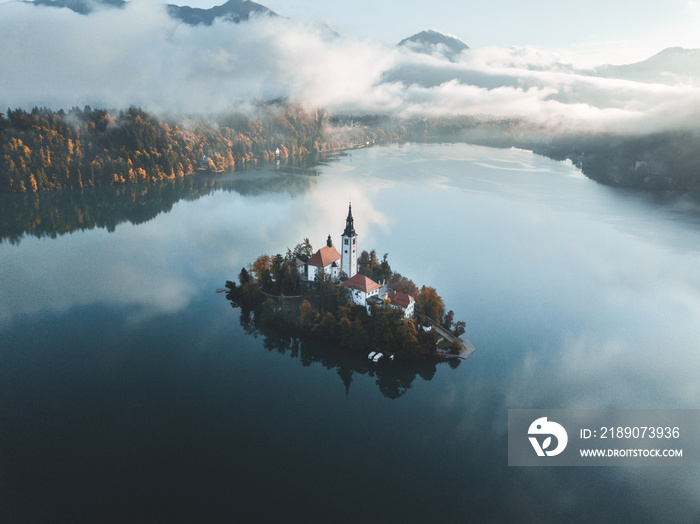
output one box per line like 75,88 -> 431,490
226,239 -> 465,360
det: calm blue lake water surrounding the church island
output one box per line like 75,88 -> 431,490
0,145 -> 700,523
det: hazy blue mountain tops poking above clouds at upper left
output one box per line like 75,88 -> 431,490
30,0 -> 277,25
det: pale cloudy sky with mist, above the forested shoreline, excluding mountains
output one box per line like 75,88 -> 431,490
0,0 -> 700,132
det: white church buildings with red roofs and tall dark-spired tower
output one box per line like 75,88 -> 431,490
296,204 -> 415,318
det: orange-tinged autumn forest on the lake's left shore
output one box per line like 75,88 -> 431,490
0,103 -> 410,193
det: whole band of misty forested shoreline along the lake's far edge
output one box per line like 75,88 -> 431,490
0,102 -> 700,193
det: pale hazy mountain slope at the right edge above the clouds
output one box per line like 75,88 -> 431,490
585,47 -> 700,85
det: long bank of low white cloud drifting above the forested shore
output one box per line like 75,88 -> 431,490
0,0 -> 700,131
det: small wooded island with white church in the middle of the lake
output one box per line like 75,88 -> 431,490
225,204 -> 474,362
